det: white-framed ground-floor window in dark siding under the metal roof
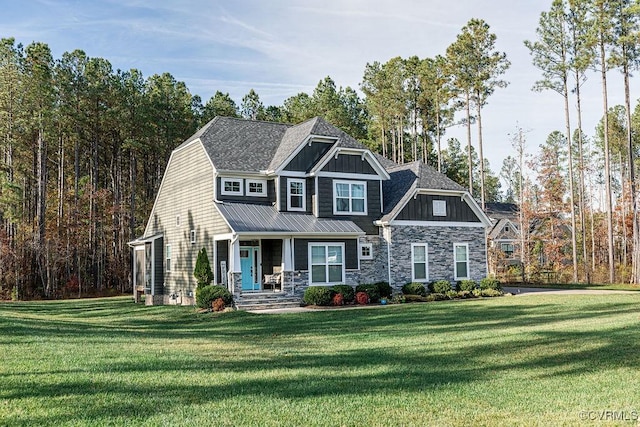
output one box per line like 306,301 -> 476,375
309,243 -> 345,285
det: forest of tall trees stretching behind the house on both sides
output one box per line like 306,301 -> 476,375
0,0 -> 639,298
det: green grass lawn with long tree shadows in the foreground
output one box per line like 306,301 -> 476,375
0,294 -> 640,426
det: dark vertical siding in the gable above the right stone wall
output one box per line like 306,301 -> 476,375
396,194 -> 481,222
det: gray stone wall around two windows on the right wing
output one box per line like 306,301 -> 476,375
391,226 -> 487,288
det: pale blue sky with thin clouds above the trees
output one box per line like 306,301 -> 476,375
0,0 -> 638,176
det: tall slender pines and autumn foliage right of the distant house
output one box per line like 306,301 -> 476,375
506,0 -> 640,283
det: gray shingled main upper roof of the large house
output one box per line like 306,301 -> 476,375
178,117 -> 365,172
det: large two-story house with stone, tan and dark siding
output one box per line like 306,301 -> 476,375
130,117 -> 490,308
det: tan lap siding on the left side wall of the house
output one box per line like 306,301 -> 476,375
145,142 -> 229,295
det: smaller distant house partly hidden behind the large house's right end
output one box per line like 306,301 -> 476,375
485,202 -> 521,274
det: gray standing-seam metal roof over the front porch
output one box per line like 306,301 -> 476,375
215,203 -> 365,235
